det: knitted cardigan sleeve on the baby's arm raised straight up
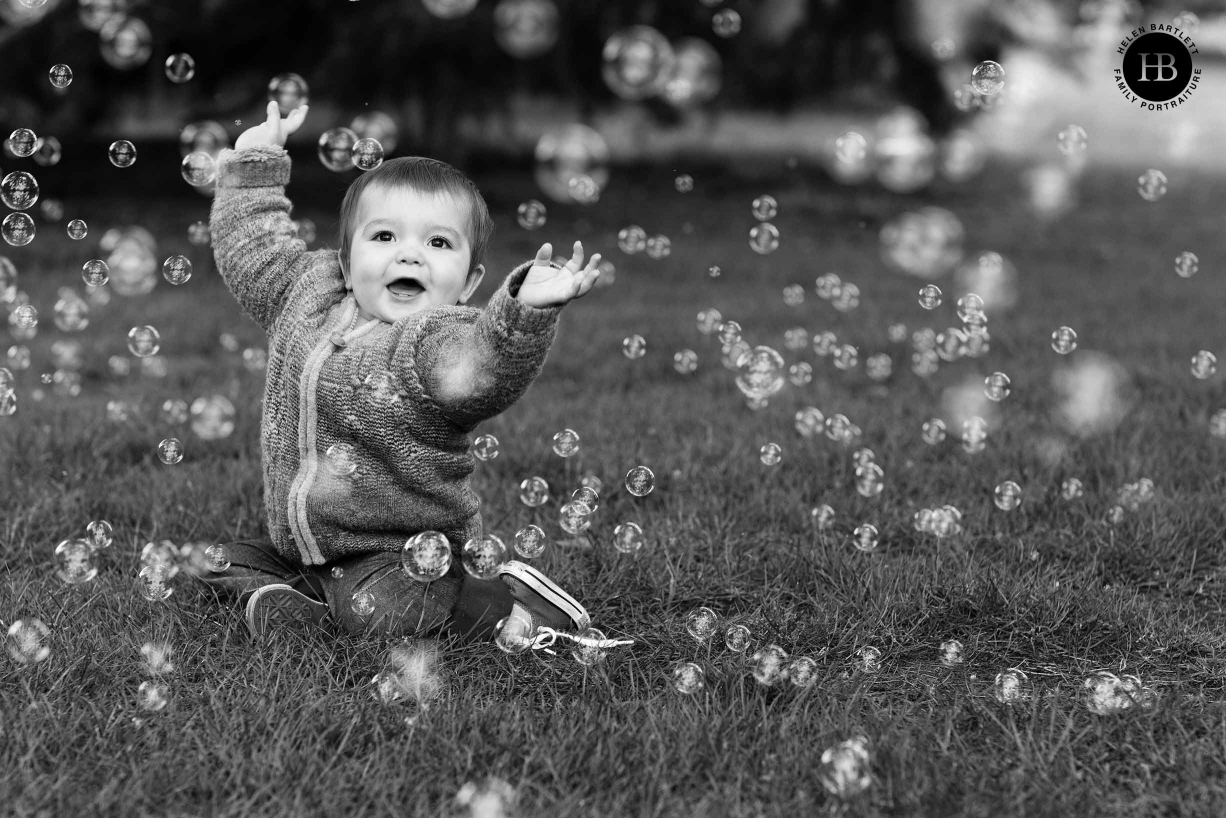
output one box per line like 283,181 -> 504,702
208,145 -> 307,331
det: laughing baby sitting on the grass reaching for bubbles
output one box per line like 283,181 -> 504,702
204,102 -> 600,640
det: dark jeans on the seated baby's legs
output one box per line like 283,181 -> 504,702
200,538 -> 512,641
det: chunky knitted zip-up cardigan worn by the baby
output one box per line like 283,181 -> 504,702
210,146 -> 562,570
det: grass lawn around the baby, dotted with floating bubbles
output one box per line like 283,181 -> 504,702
0,149 -> 1226,818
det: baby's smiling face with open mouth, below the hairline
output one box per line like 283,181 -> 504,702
348,185 -> 484,324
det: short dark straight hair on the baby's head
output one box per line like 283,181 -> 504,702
338,156 -> 494,277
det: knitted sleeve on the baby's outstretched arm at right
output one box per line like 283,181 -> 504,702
414,261 -> 562,430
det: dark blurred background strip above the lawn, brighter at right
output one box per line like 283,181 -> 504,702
0,0 -> 1226,180
